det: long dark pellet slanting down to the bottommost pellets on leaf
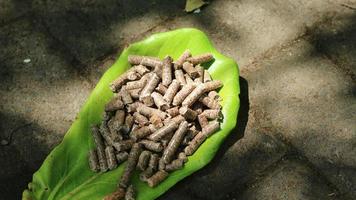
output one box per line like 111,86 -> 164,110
119,143 -> 141,188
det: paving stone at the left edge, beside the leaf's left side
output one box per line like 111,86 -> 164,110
0,19 -> 92,199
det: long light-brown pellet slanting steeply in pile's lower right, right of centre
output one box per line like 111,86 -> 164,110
162,121 -> 188,164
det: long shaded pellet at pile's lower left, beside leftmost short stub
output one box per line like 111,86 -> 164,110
91,126 -> 108,172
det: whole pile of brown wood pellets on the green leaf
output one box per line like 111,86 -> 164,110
89,50 -> 222,199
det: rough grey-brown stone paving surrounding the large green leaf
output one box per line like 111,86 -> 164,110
0,0 -> 356,199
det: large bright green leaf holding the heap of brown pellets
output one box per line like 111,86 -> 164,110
23,28 -> 240,200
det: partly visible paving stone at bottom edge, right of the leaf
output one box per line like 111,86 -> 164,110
236,159 -> 341,200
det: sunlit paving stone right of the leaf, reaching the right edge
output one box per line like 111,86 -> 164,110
242,40 -> 356,197
